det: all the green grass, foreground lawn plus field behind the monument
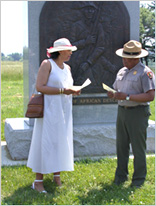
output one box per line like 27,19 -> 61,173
1,62 -> 155,205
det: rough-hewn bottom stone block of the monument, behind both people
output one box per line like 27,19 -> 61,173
5,118 -> 155,160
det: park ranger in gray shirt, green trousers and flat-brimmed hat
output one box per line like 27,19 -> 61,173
108,40 -> 155,187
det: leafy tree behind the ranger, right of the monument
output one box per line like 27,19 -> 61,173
140,1 -> 155,65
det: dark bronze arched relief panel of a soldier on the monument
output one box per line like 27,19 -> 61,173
39,1 -> 130,94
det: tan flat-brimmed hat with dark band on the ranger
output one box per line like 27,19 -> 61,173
116,40 -> 148,58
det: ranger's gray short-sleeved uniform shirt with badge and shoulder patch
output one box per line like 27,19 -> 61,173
113,62 -> 155,107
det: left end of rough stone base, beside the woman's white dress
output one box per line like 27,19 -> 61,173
5,118 -> 33,160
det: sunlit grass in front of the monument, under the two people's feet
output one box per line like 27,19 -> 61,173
1,157 -> 155,205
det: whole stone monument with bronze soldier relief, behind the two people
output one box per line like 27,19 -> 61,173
5,1 -> 155,159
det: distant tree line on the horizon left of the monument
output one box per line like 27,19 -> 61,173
1,52 -> 23,61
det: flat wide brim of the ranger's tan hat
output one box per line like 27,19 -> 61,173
115,49 -> 148,59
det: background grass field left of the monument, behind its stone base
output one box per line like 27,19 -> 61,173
1,61 -> 24,141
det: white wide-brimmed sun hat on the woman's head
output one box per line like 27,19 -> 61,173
47,38 -> 77,53
